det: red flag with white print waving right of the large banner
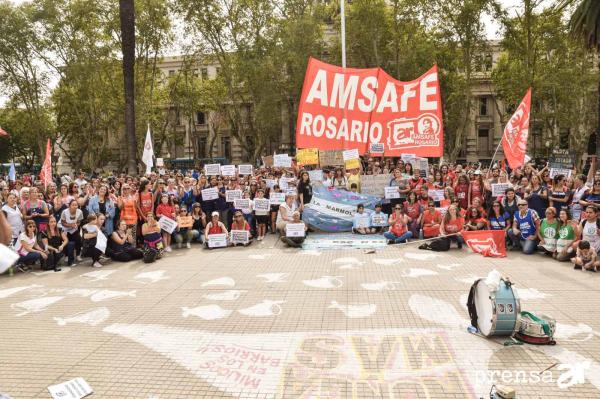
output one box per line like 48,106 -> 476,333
502,88 -> 531,169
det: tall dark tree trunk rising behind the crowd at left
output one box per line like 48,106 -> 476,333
119,0 -> 138,175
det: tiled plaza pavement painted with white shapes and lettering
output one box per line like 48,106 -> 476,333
0,236 -> 600,399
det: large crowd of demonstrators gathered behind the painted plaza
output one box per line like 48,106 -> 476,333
0,157 -> 600,271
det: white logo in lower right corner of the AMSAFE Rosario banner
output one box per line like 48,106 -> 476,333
387,114 -> 440,150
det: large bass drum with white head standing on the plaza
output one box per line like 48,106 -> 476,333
467,279 -> 521,337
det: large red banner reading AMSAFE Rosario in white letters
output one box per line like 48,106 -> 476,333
296,58 -> 444,157
